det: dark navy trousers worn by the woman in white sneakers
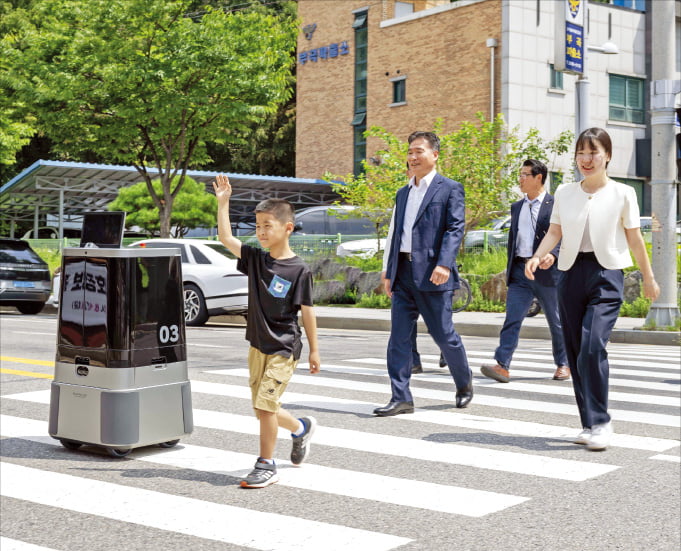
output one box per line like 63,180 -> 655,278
558,253 -> 624,428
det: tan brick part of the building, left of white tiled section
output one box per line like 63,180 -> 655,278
296,0 -> 501,177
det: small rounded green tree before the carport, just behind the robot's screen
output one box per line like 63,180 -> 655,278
108,176 -> 218,237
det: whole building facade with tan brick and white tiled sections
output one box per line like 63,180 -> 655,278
296,0 -> 681,214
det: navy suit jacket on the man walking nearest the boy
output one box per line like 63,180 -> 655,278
386,174 -> 465,292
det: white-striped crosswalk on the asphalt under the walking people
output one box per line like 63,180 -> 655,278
0,345 -> 681,551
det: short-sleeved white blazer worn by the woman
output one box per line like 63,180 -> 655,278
551,179 -> 641,271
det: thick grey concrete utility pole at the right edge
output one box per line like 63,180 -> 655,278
646,0 -> 681,327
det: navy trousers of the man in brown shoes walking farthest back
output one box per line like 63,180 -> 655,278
494,260 -> 569,369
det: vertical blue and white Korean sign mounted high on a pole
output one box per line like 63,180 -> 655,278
554,0 -> 587,74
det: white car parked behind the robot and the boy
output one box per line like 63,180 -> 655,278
129,239 -> 248,326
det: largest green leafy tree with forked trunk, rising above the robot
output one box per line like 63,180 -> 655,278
5,0 -> 297,237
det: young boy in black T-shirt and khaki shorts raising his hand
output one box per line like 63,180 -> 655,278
213,174 -> 319,488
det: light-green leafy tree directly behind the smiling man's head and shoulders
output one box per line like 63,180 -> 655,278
325,113 -> 572,245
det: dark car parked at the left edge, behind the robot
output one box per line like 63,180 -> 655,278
0,238 -> 52,314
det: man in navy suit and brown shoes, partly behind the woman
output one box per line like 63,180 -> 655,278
480,159 -> 570,383
